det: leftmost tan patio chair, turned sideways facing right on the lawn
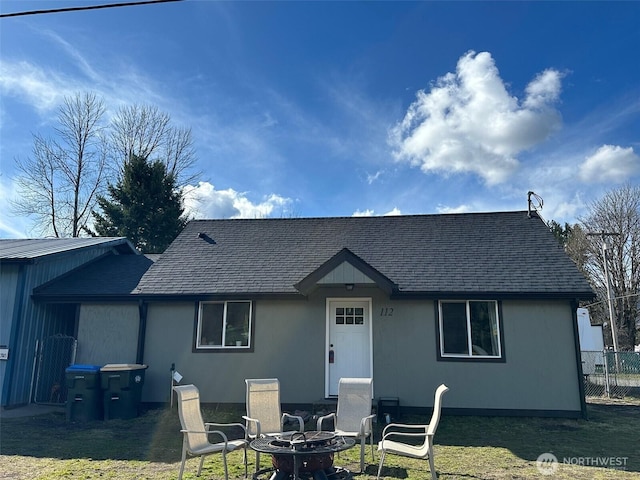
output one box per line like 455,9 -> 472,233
173,385 -> 247,480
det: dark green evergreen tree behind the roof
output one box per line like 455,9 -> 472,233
93,155 -> 187,253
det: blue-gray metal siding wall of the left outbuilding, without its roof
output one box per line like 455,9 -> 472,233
1,246 -> 116,407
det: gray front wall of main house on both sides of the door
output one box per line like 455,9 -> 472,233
143,288 -> 581,412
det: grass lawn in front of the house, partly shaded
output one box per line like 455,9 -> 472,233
0,404 -> 640,480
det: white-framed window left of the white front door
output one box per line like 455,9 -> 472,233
196,301 -> 251,349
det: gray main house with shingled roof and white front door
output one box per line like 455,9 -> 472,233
34,211 -> 594,417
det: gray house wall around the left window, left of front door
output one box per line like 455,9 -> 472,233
143,301 -> 325,403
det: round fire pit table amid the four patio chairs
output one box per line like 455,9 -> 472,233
251,431 -> 355,480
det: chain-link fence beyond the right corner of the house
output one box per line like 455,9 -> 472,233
581,351 -> 640,398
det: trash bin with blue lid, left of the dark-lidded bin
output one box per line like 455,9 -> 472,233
65,365 -> 103,422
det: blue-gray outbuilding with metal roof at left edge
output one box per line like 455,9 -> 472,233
0,238 -> 139,407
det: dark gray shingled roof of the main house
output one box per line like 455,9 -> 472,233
136,211 -> 593,298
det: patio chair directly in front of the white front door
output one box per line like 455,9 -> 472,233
317,378 -> 375,472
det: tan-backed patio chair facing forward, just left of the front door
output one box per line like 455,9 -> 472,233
242,378 -> 304,472
